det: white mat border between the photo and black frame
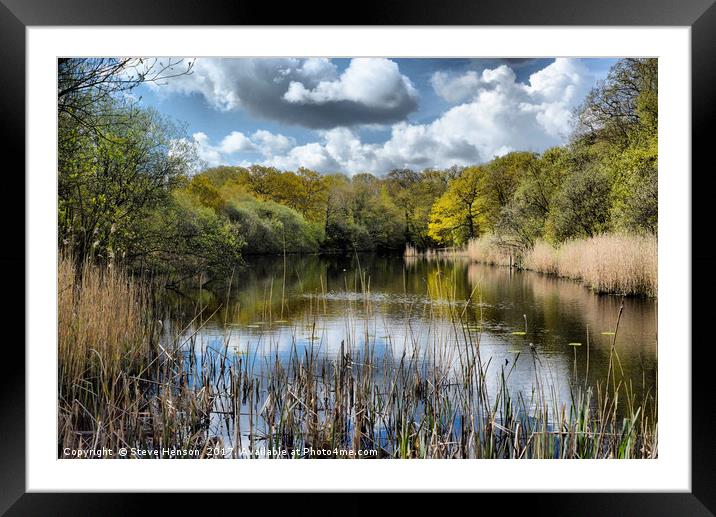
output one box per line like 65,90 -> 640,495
26,27 -> 691,492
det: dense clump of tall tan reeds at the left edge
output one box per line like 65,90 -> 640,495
58,255 -> 159,454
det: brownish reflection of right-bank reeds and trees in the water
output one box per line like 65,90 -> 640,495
467,264 -> 657,402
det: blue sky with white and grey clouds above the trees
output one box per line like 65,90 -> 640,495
137,58 -> 615,174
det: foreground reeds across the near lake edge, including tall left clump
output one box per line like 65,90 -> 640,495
58,252 -> 658,458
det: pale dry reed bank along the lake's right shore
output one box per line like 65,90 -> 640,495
467,234 -> 658,296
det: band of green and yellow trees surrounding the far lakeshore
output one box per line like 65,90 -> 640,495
58,59 -> 658,275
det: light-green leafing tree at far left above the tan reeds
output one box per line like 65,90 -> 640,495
58,99 -> 193,261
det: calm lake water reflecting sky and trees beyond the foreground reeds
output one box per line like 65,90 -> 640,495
165,254 -> 657,456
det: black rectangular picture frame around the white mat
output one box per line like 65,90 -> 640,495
0,0 -> 716,515
